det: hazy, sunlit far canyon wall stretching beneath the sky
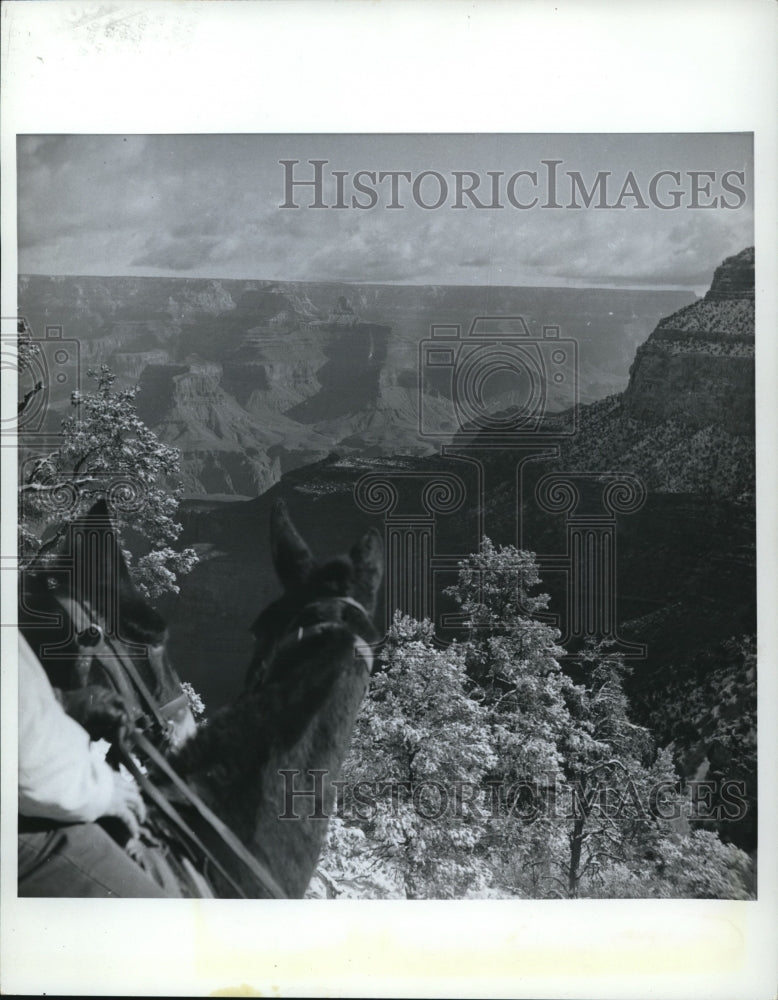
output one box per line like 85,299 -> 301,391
19,275 -> 704,495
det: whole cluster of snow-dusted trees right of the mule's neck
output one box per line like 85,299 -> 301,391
320,539 -> 750,898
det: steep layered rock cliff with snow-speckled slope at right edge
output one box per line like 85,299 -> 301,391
562,248 -> 755,499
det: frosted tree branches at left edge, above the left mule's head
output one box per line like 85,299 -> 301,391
19,365 -> 197,598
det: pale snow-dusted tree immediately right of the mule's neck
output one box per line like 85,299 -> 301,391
323,615 -> 494,898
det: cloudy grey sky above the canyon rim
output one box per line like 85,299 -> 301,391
17,134 -> 753,291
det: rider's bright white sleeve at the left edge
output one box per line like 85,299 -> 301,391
19,635 -> 114,823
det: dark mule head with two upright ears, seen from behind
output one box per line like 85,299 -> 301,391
248,500 -> 384,686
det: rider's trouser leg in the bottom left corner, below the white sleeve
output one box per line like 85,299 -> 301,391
18,823 -> 180,898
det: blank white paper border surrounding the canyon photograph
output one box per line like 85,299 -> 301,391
0,0 -> 778,1000
